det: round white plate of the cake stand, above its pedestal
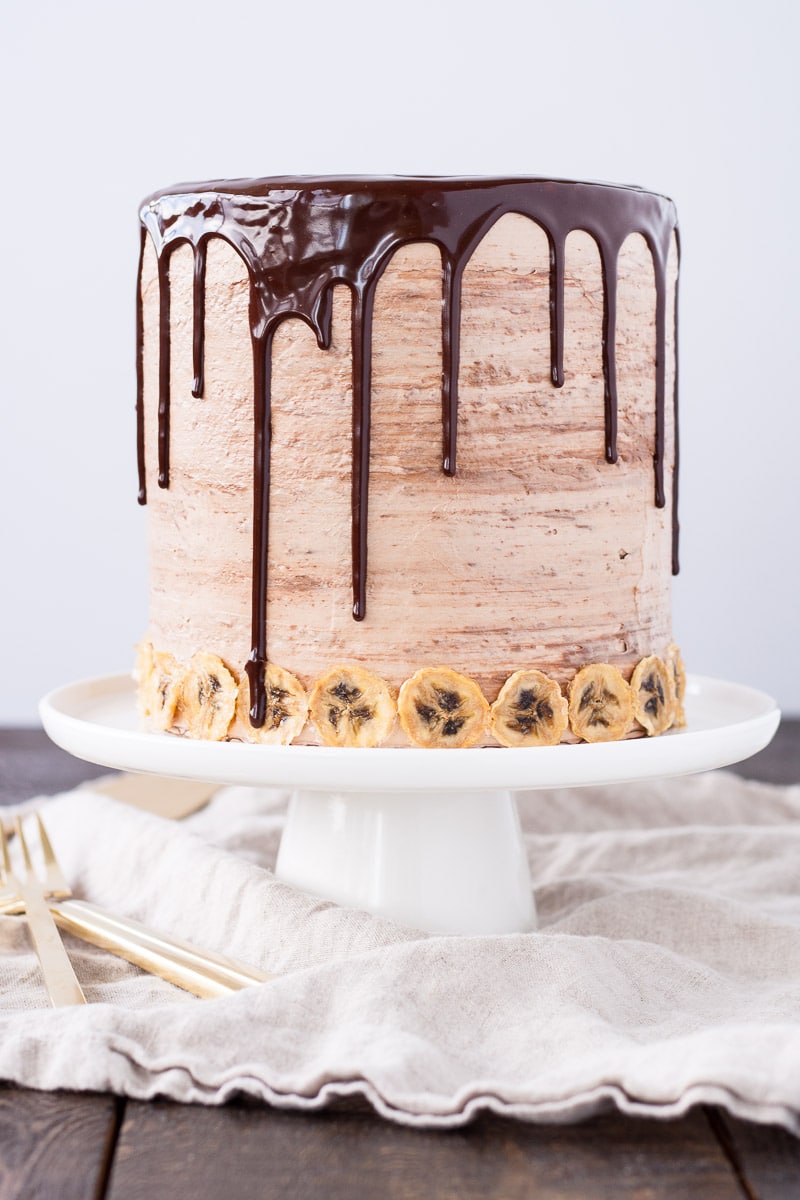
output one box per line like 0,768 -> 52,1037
40,673 -> 781,792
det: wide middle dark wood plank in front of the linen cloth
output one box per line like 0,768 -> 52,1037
108,1100 -> 742,1200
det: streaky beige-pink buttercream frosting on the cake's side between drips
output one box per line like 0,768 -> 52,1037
137,214 -> 676,743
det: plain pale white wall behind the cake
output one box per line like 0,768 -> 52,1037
0,0 -> 800,724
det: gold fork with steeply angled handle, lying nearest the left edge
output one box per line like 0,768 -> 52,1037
0,820 -> 86,1007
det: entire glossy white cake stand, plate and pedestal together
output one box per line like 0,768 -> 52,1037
40,674 -> 781,934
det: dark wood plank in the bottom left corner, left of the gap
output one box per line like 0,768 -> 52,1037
0,1085 -> 121,1200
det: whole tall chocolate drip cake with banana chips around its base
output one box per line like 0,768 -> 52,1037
137,176 -> 682,746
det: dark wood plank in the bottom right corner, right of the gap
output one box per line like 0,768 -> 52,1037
718,1112 -> 800,1200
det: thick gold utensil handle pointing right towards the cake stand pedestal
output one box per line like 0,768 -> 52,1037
49,900 -> 272,998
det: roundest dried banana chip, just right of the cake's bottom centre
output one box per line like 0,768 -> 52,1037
397,667 -> 489,749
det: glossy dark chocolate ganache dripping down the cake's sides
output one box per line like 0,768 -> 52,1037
137,176 -> 678,726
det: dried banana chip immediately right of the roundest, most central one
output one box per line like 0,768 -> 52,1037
489,671 -> 569,746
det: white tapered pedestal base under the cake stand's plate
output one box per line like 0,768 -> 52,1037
275,791 -> 536,934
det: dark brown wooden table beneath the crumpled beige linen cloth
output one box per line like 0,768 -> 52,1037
0,720 -> 800,1200
